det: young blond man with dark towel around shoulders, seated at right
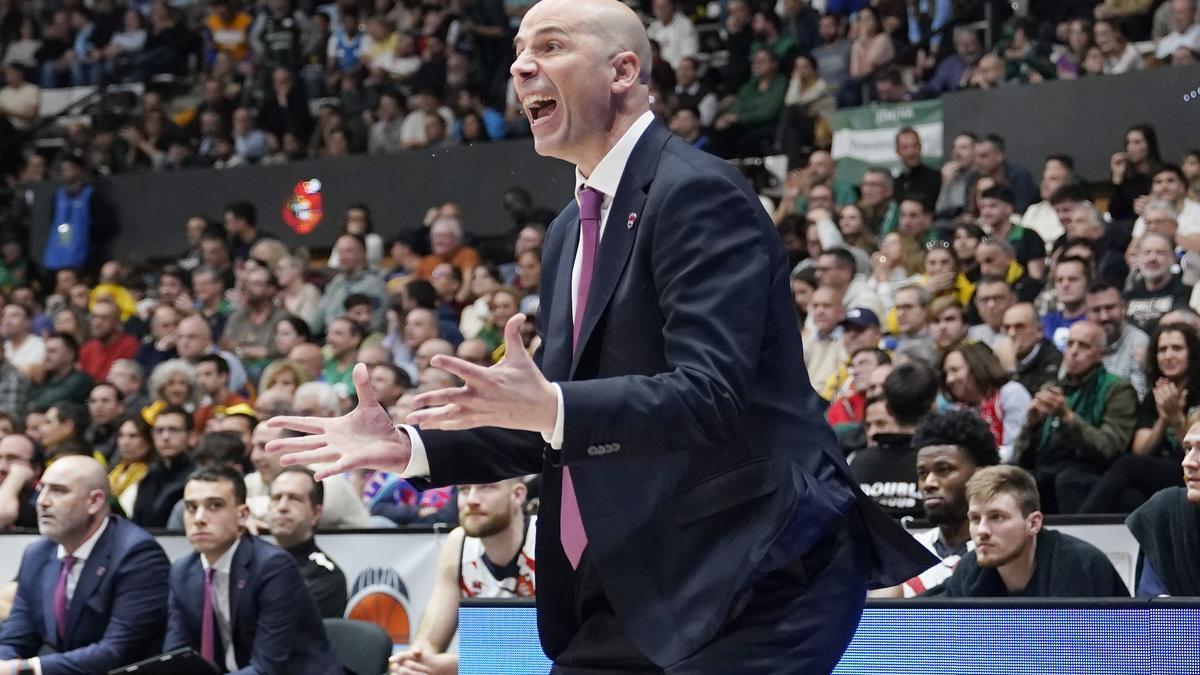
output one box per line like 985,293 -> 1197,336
943,465 -> 1129,598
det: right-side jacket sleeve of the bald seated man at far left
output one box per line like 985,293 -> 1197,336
42,540 -> 170,675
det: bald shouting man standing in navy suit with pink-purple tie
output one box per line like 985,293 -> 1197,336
269,0 -> 936,673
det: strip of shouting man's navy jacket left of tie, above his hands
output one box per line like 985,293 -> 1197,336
541,199 -> 580,381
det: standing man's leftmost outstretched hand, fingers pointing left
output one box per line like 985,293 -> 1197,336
266,363 -> 413,480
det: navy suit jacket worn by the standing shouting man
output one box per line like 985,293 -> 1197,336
421,121 -> 936,665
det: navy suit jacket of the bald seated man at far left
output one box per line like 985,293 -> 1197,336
0,515 -> 170,675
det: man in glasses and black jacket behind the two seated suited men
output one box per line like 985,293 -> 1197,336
133,406 -> 196,527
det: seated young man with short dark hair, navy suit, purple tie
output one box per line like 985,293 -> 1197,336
163,466 -> 341,675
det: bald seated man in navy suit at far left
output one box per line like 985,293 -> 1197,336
0,456 -> 170,675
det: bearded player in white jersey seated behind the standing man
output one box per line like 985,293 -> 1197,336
389,478 -> 538,675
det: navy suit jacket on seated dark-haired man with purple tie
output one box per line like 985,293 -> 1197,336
163,534 -> 342,675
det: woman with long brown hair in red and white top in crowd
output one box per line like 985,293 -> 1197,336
940,342 -> 1032,461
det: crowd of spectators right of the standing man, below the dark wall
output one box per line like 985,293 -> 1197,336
775,119 -> 1200,515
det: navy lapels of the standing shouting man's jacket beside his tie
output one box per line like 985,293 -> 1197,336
566,121 -> 671,377
